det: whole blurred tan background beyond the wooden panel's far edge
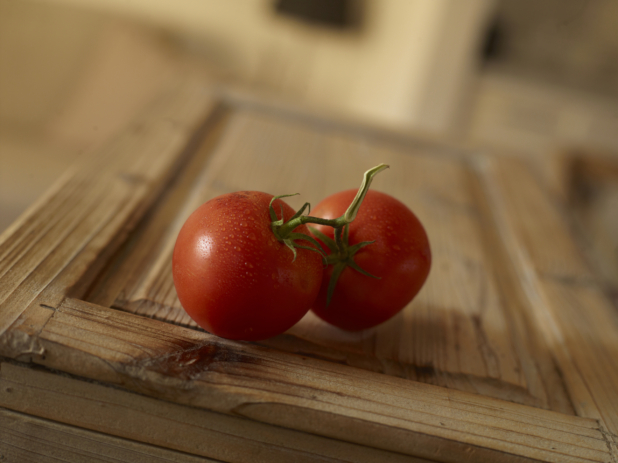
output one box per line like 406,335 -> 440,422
0,0 -> 618,231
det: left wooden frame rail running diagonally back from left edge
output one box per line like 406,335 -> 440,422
0,78 -> 215,333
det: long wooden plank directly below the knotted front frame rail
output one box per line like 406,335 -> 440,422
0,363 -> 429,463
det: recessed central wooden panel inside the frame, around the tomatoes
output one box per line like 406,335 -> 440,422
85,110 -> 573,413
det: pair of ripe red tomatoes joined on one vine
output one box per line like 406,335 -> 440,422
173,170 -> 431,341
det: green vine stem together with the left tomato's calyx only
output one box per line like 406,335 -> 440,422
269,164 -> 389,262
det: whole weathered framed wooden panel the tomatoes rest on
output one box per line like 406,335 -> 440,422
0,81 -> 618,462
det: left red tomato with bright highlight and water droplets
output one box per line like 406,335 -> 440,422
172,191 -> 324,341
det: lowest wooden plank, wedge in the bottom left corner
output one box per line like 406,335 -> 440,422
0,408 -> 217,463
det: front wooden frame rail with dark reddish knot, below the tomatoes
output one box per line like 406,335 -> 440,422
1,300 -> 611,462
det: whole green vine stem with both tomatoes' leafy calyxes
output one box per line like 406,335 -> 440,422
269,164 -> 388,305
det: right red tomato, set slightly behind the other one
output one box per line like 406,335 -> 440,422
312,190 -> 431,331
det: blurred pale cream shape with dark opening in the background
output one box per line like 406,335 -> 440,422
3,0 -> 493,132
